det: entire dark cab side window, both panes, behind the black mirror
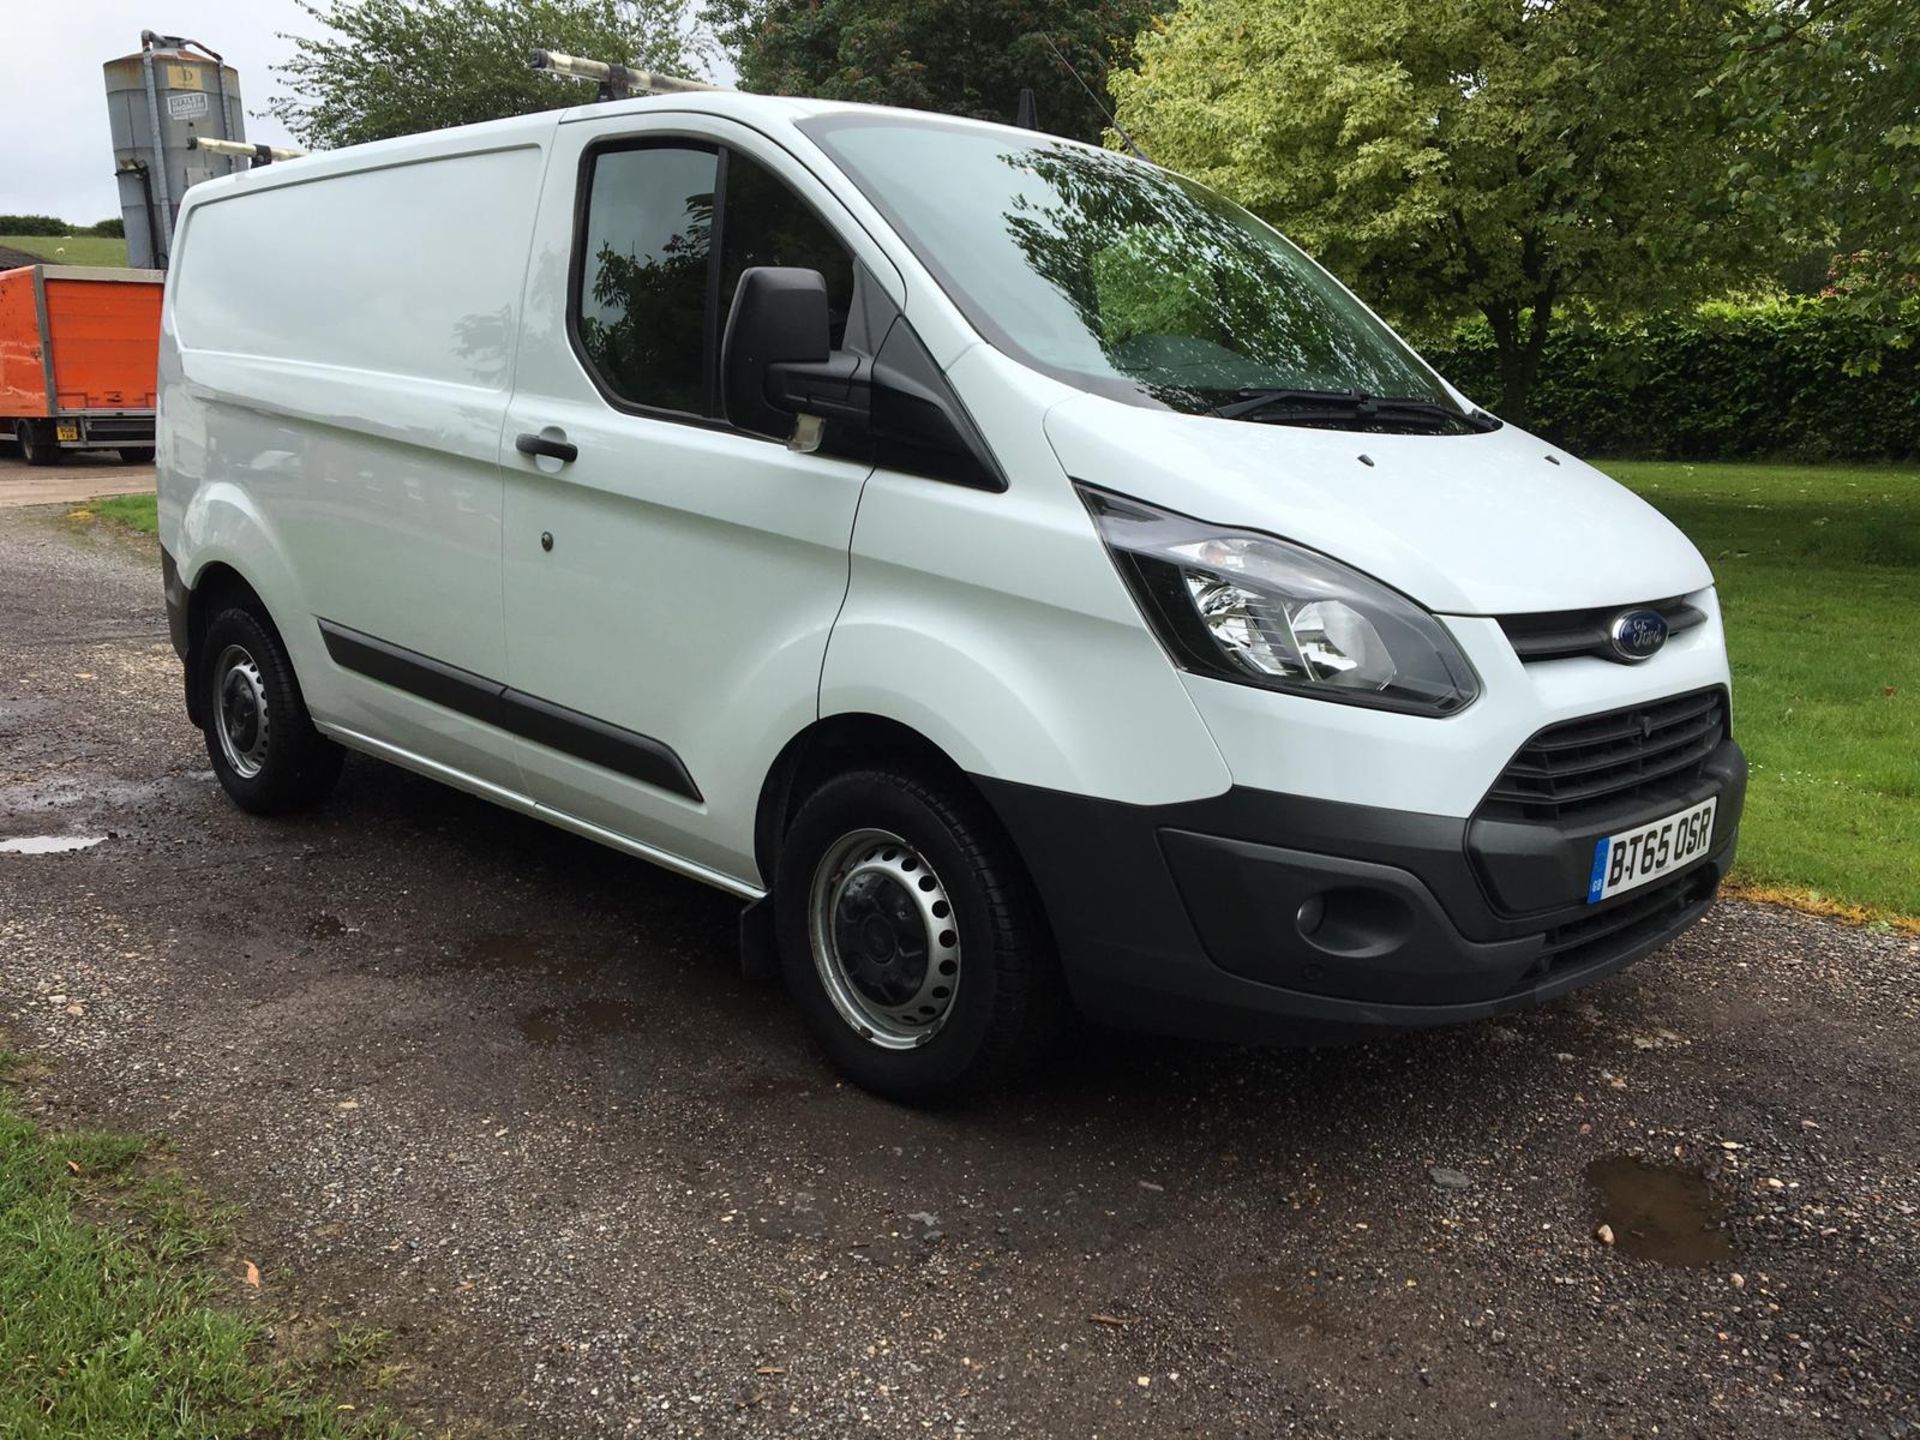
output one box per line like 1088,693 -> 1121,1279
572,140 -> 852,419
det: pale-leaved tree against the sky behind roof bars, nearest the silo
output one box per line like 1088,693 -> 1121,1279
267,0 -> 708,148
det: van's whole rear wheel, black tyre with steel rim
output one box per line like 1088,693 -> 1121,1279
198,607 -> 344,814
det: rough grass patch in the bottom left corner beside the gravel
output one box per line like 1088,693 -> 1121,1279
0,1052 -> 403,1440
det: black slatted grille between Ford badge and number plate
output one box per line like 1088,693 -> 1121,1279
1480,687 -> 1726,820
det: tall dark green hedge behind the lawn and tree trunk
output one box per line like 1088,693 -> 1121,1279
1425,300 -> 1920,461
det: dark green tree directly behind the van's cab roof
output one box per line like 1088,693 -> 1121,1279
708,0 -> 1171,140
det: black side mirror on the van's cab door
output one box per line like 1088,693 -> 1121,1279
720,265 -> 868,449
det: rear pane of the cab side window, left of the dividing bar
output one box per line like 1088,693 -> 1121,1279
574,146 -> 720,415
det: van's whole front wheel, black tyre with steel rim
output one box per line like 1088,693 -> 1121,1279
774,770 -> 1066,1102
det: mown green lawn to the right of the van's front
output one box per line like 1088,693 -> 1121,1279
1603,461 -> 1920,918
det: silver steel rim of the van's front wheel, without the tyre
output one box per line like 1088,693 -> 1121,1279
806,829 -> 960,1050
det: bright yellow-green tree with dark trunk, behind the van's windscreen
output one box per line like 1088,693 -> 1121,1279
1112,0 -> 1782,424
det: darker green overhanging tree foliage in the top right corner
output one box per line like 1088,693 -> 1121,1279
1713,0 -> 1920,367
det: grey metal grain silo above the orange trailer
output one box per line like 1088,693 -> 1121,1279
104,31 -> 246,269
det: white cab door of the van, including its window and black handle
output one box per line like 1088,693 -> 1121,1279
501,115 -> 883,889
